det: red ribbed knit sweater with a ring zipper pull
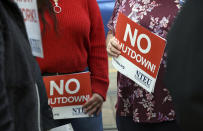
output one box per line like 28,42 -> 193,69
37,0 -> 108,99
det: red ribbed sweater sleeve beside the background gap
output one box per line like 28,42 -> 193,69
87,0 -> 109,100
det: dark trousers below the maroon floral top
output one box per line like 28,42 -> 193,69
116,115 -> 181,131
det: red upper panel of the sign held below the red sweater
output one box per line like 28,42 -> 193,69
43,72 -> 92,107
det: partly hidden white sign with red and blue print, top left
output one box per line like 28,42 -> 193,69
14,0 -> 43,57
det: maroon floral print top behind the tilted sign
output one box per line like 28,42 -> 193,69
108,0 -> 180,123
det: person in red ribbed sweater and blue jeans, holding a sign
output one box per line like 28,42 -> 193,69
37,0 -> 108,131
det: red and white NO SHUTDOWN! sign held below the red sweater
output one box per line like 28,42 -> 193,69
43,72 -> 92,119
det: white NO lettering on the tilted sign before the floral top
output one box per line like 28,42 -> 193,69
123,24 -> 151,54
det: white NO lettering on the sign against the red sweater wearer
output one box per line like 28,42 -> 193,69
50,78 -> 80,96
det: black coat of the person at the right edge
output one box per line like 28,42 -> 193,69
165,0 -> 203,131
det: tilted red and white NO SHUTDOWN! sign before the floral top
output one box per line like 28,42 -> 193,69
112,13 -> 165,92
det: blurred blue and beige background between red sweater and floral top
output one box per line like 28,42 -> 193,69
97,0 -> 117,131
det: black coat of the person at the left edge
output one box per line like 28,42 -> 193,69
0,0 -> 53,131
